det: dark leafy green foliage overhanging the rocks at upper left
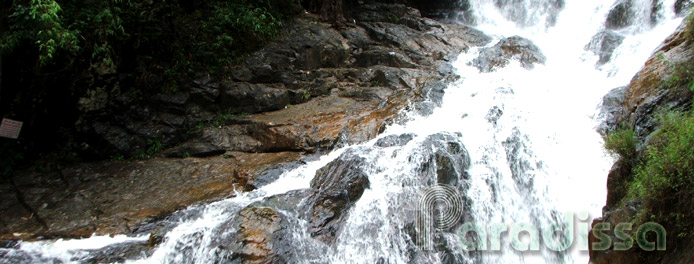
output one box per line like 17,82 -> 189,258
0,0 -> 298,88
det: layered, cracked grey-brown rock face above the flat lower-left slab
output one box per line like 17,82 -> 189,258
80,4 -> 489,157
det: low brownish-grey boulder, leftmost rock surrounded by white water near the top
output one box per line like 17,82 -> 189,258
472,36 -> 546,72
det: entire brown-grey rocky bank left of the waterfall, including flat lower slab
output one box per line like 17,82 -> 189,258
0,4 -> 490,240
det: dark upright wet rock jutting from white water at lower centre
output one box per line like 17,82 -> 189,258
309,151 -> 369,244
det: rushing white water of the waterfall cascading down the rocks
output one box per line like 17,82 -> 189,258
0,0 -> 681,263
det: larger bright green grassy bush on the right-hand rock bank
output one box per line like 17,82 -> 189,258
627,109 -> 694,239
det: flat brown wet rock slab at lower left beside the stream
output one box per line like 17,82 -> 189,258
0,152 -> 301,239
